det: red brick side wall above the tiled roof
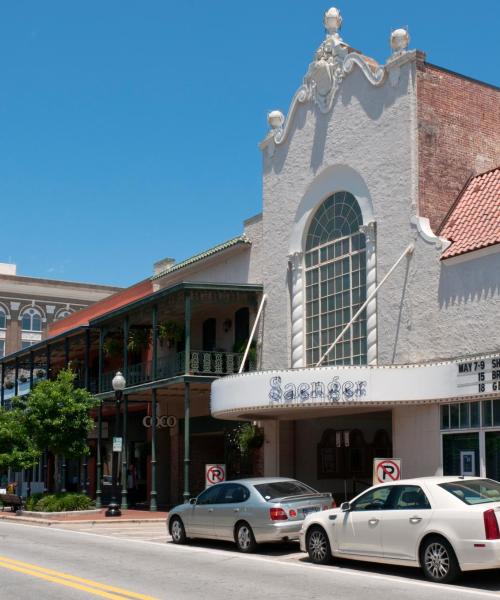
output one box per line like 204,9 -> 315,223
417,55 -> 500,231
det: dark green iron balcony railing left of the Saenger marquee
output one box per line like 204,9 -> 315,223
96,350 -> 256,392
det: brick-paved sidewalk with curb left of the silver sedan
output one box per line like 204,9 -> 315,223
0,508 -> 168,525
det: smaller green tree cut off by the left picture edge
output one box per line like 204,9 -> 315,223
0,408 -> 40,471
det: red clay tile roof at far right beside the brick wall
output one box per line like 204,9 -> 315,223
439,167 -> 500,258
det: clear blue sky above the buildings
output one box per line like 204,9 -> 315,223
0,0 -> 500,285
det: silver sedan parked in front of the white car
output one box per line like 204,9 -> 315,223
167,477 -> 335,552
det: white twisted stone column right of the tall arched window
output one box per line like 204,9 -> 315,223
359,221 -> 378,365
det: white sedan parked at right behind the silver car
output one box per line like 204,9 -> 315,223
300,477 -> 500,583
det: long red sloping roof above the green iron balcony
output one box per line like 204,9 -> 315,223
48,279 -> 153,337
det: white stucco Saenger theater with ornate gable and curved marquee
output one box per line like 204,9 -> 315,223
211,9 -> 500,496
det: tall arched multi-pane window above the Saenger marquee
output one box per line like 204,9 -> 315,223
305,192 -> 366,365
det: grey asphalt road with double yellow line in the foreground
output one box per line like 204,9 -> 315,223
0,522 -> 500,600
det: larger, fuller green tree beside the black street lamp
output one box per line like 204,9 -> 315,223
26,369 -> 98,457
